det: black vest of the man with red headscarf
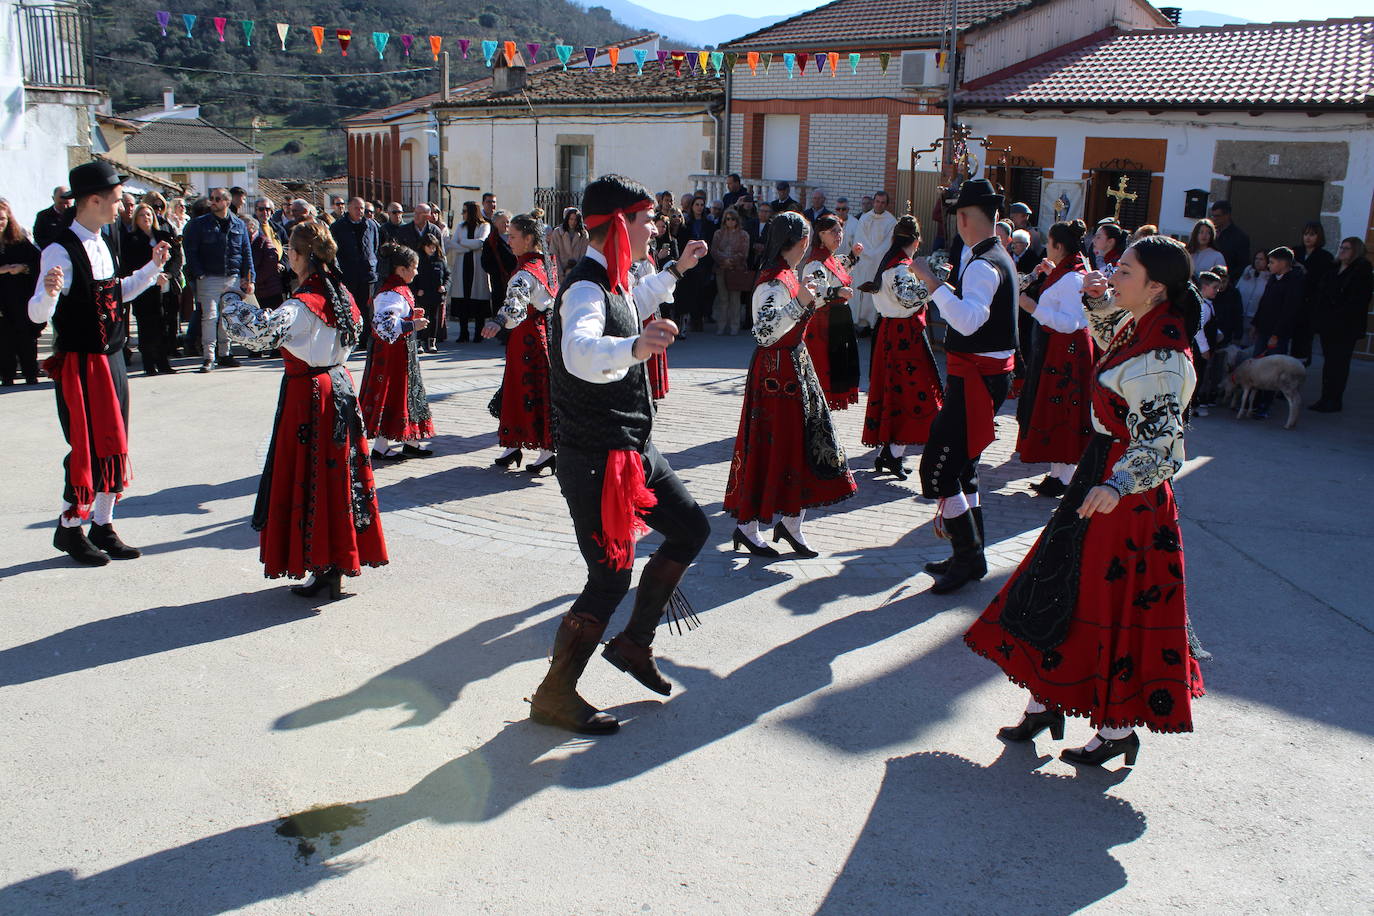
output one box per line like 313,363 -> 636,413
548,257 -> 654,452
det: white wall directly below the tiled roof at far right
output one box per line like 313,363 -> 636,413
960,111 -> 1374,238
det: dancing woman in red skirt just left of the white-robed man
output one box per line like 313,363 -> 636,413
801,213 -> 863,411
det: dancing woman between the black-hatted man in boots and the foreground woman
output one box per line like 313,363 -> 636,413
1017,220 -> 1092,497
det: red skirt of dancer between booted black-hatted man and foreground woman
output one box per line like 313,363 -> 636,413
1017,328 -> 1094,464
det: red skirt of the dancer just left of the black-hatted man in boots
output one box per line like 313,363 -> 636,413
863,317 -> 944,448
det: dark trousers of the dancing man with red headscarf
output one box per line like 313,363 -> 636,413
558,442 -> 710,622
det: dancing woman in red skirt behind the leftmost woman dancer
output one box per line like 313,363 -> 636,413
359,242 -> 442,460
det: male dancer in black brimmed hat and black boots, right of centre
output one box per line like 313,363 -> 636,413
911,179 -> 1017,595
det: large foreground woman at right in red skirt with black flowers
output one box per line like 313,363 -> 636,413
965,236 -> 1202,766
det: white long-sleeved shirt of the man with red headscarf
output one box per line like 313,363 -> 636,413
558,246 -> 677,385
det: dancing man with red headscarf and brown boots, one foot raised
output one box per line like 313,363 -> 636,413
530,174 -> 710,735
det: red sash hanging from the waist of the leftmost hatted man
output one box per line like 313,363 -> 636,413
43,353 -> 131,519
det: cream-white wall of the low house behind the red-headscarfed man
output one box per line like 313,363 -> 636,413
444,111 -> 714,213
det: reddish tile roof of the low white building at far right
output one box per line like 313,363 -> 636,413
958,18 -> 1374,110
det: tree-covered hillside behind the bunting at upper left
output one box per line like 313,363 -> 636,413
91,0 -> 639,179
